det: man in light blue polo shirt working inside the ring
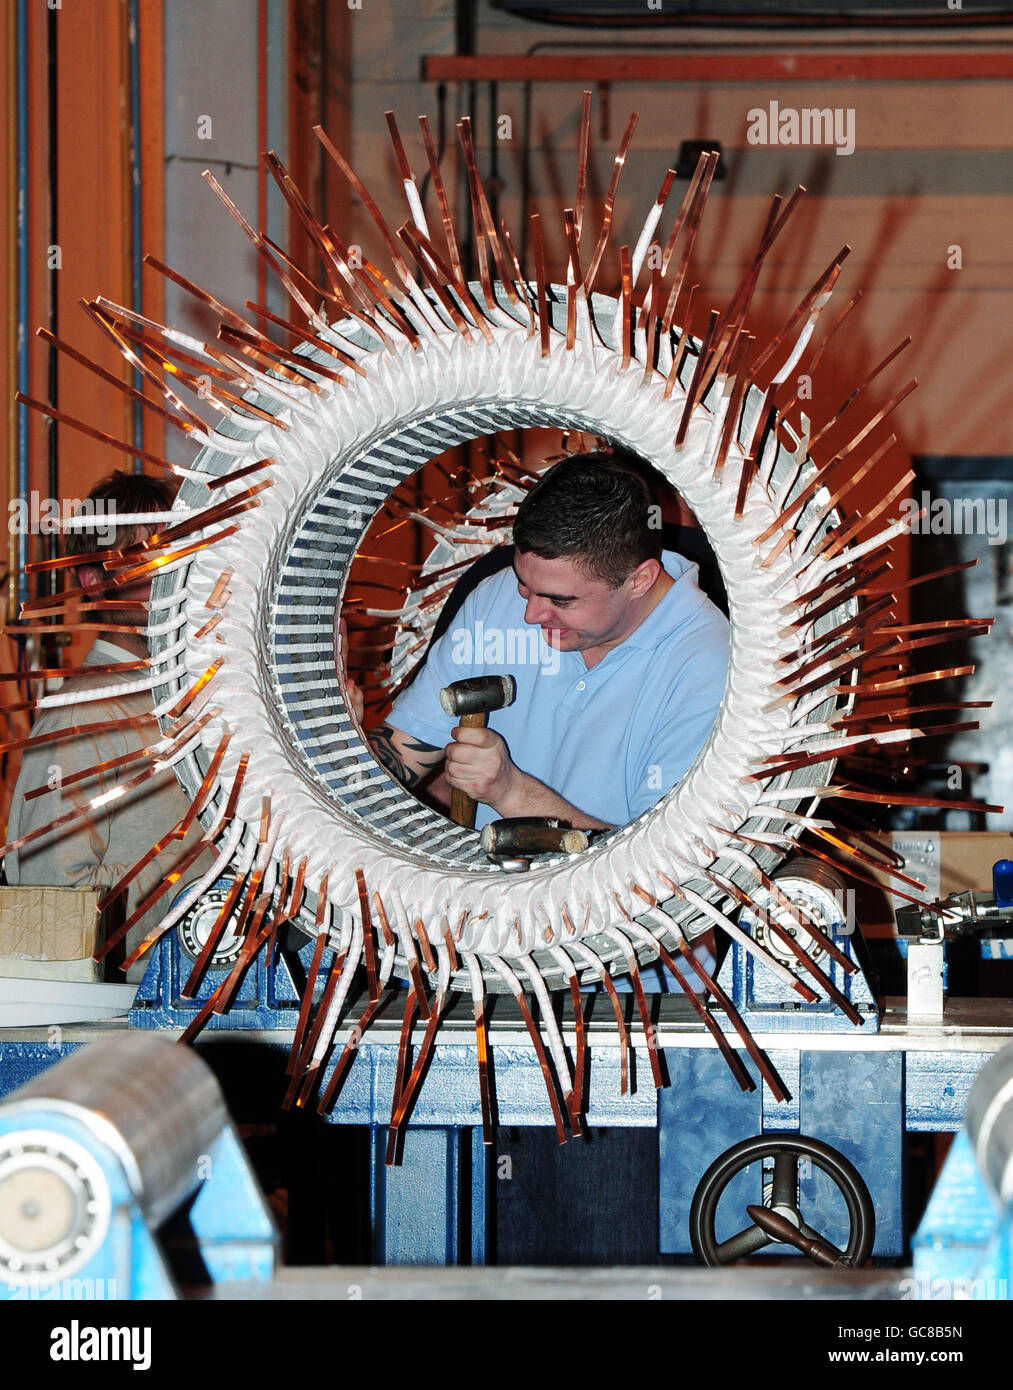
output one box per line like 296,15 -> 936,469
350,453 -> 728,828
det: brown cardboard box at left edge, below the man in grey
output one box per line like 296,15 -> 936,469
0,888 -> 101,980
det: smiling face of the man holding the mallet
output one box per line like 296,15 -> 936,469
514,550 -> 635,652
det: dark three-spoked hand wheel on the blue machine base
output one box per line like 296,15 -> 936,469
689,1134 -> 875,1268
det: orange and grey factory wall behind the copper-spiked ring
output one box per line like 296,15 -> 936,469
0,0 -> 1013,809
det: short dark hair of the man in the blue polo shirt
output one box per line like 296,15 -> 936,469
514,450 -> 661,589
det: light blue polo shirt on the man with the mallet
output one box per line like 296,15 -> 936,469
388,550 -> 728,827
